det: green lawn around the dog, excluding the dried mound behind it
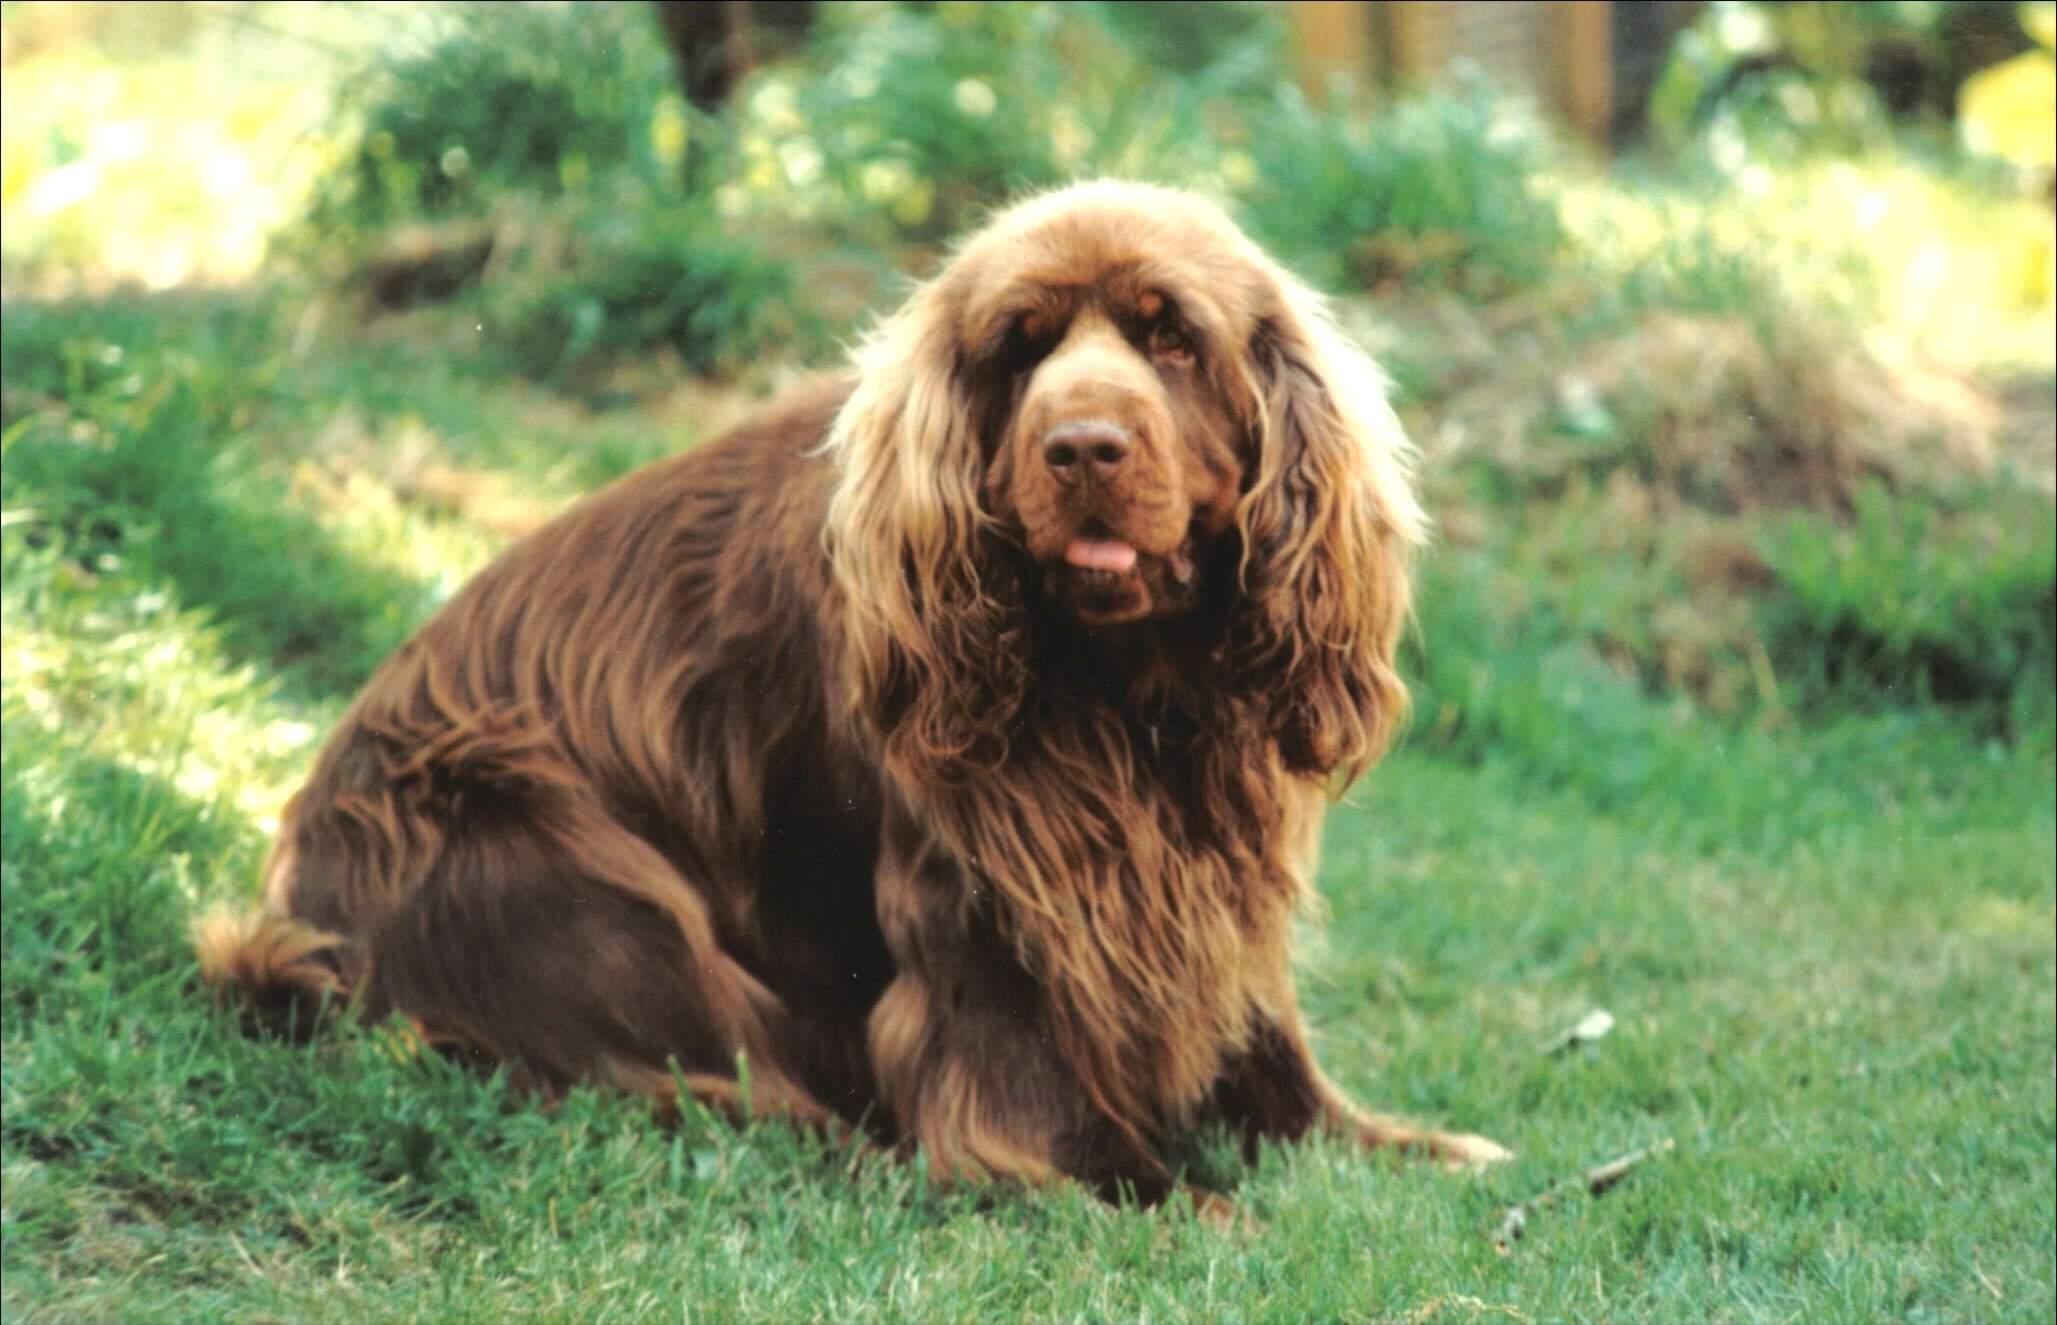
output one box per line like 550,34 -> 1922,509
0,277 -> 2057,1321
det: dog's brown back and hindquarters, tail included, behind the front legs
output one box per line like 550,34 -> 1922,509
197,383 -> 889,1117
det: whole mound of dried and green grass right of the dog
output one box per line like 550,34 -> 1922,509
1395,305 -> 2051,712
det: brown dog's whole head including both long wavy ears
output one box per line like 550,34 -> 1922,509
829,183 -> 1421,772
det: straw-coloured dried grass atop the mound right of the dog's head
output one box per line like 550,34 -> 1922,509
1415,307 -> 2007,516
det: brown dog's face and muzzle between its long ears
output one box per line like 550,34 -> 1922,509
952,195 -> 1257,628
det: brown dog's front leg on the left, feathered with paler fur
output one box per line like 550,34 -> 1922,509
868,815 -> 1172,1204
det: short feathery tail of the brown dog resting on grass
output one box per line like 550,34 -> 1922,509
193,909 -> 350,1039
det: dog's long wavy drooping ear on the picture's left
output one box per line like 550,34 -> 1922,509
825,278 -> 1026,780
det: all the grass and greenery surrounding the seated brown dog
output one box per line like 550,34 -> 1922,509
0,0 -> 2057,1321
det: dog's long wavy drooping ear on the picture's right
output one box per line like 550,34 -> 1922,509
1234,272 -> 1426,778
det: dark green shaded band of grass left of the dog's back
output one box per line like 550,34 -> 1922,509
4,296 -> 434,700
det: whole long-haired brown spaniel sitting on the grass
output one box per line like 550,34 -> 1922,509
200,183 -> 1504,1199
